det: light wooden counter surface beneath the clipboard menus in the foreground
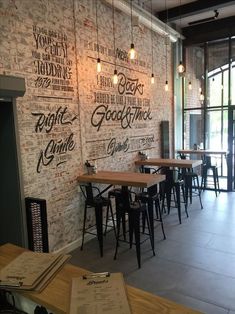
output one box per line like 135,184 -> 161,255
0,244 -> 200,314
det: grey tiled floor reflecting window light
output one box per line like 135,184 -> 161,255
71,191 -> 235,314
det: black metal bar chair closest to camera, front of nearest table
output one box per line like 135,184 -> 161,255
114,188 -> 155,268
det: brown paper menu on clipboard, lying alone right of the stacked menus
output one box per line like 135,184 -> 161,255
69,273 -> 131,314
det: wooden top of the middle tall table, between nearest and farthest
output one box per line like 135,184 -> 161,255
135,158 -> 202,168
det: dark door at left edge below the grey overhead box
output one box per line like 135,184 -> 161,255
0,101 -> 24,246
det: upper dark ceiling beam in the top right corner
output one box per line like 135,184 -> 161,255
155,0 -> 235,22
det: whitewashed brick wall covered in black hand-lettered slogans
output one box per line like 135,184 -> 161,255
0,0 -> 173,251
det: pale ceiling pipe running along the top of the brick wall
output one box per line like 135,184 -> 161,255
105,0 -> 184,42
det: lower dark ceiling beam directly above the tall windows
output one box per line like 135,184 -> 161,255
182,16 -> 235,46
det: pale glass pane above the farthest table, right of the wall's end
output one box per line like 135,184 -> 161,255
184,109 -> 204,149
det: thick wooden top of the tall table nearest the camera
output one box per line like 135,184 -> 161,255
77,171 -> 166,188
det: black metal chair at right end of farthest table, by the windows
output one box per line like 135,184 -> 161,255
201,155 -> 220,196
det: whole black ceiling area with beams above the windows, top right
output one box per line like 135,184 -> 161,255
155,0 -> 235,45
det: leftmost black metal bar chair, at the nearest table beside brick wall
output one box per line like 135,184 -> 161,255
80,184 -> 116,257
